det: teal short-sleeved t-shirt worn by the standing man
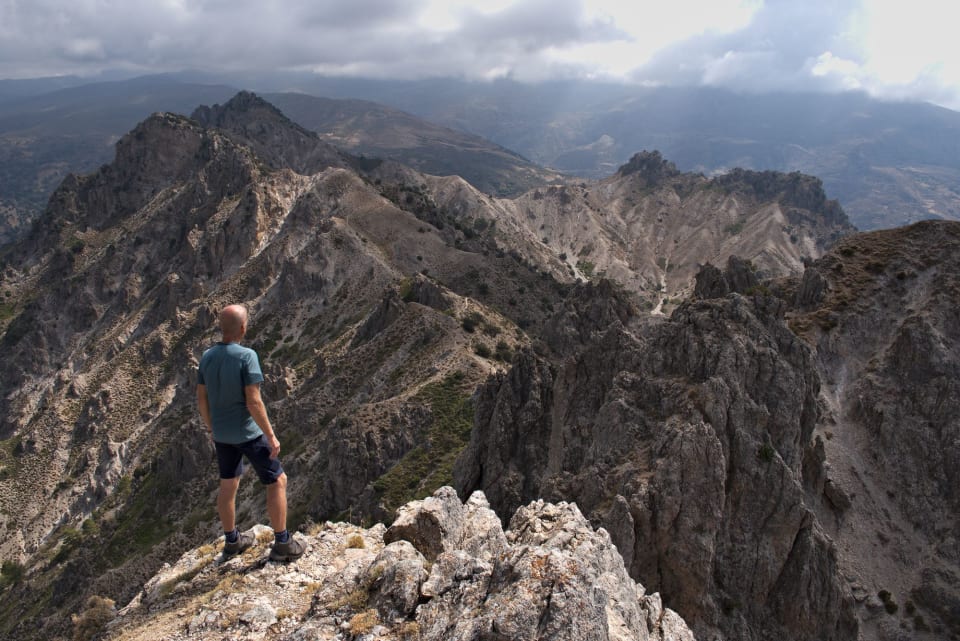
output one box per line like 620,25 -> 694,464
197,343 -> 263,444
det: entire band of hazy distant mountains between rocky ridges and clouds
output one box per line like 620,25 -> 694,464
0,74 -> 960,241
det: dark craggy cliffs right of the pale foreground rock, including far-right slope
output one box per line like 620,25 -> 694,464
455,223 -> 960,639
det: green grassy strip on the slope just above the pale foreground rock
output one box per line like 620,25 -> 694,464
373,372 -> 474,512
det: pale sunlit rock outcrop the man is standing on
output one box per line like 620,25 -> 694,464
101,487 -> 694,641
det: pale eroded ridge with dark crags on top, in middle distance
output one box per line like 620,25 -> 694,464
424,152 -> 854,313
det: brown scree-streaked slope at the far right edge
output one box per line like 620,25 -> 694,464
790,221 -> 960,639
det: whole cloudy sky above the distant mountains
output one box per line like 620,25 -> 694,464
0,0 -> 960,109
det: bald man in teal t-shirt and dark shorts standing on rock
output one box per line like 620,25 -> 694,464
197,305 -> 304,561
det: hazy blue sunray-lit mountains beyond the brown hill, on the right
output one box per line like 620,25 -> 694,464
294,81 -> 960,229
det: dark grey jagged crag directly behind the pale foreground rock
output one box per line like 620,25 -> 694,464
455,263 -> 857,640
